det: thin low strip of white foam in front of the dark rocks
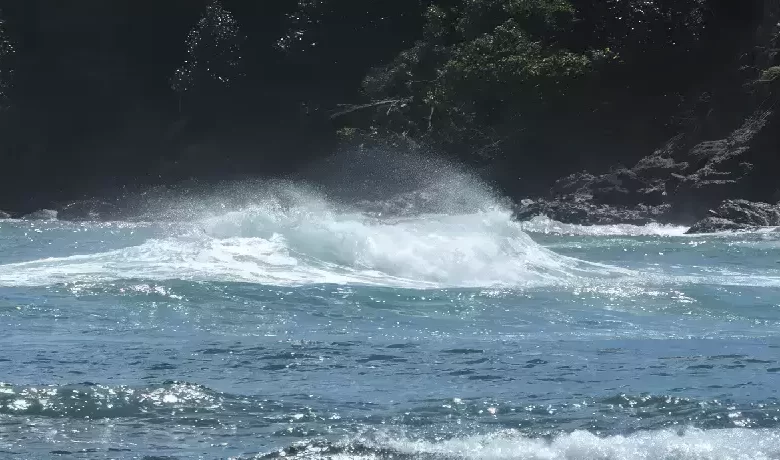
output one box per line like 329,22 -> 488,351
520,216 -> 689,237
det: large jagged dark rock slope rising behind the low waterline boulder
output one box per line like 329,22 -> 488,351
517,75 -> 780,229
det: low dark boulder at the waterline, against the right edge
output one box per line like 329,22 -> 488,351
688,200 -> 780,234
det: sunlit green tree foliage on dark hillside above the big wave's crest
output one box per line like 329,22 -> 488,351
348,0 -> 596,153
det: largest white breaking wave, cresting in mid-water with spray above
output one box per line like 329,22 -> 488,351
0,187 -> 628,289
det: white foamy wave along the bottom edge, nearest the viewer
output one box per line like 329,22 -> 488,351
255,429 -> 780,460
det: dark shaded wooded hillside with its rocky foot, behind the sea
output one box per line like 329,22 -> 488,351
0,0 -> 780,231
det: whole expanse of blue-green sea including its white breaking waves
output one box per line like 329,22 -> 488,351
0,181 -> 780,460
